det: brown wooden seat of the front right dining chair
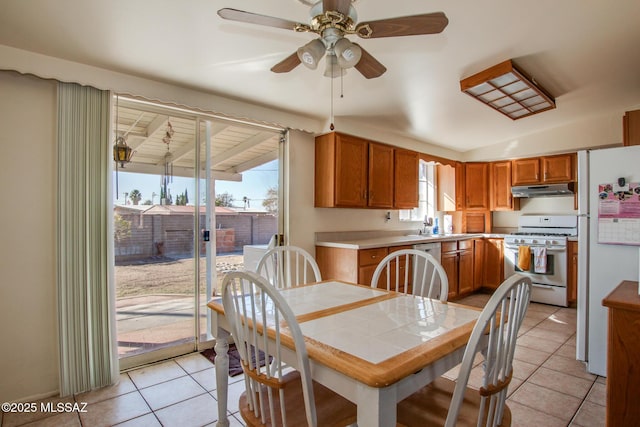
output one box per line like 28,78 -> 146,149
398,377 -> 511,427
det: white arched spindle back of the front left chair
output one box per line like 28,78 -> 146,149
222,271 -> 317,427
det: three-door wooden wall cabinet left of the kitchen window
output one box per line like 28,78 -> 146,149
315,132 -> 419,209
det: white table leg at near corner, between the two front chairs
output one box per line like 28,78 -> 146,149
357,384 -> 397,427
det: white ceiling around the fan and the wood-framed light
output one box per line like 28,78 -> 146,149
0,0 -> 640,152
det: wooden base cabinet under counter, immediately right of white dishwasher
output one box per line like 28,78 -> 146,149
441,239 -> 474,300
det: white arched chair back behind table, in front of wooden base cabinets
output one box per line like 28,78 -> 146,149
371,249 -> 449,301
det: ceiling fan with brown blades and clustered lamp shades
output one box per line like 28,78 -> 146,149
218,0 -> 449,79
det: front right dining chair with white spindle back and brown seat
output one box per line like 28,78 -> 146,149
398,274 -> 531,427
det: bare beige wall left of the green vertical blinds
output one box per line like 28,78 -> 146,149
0,72 -> 58,402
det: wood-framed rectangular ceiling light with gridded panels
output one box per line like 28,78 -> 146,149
460,59 -> 556,120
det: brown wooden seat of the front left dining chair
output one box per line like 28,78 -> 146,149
240,371 -> 357,427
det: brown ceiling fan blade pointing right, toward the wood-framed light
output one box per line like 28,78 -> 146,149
356,12 -> 449,39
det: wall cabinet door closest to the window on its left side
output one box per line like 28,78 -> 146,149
393,148 -> 420,209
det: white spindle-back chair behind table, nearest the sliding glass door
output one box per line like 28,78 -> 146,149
256,245 -> 322,289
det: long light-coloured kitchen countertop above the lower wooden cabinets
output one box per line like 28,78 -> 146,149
316,233 -> 504,249
